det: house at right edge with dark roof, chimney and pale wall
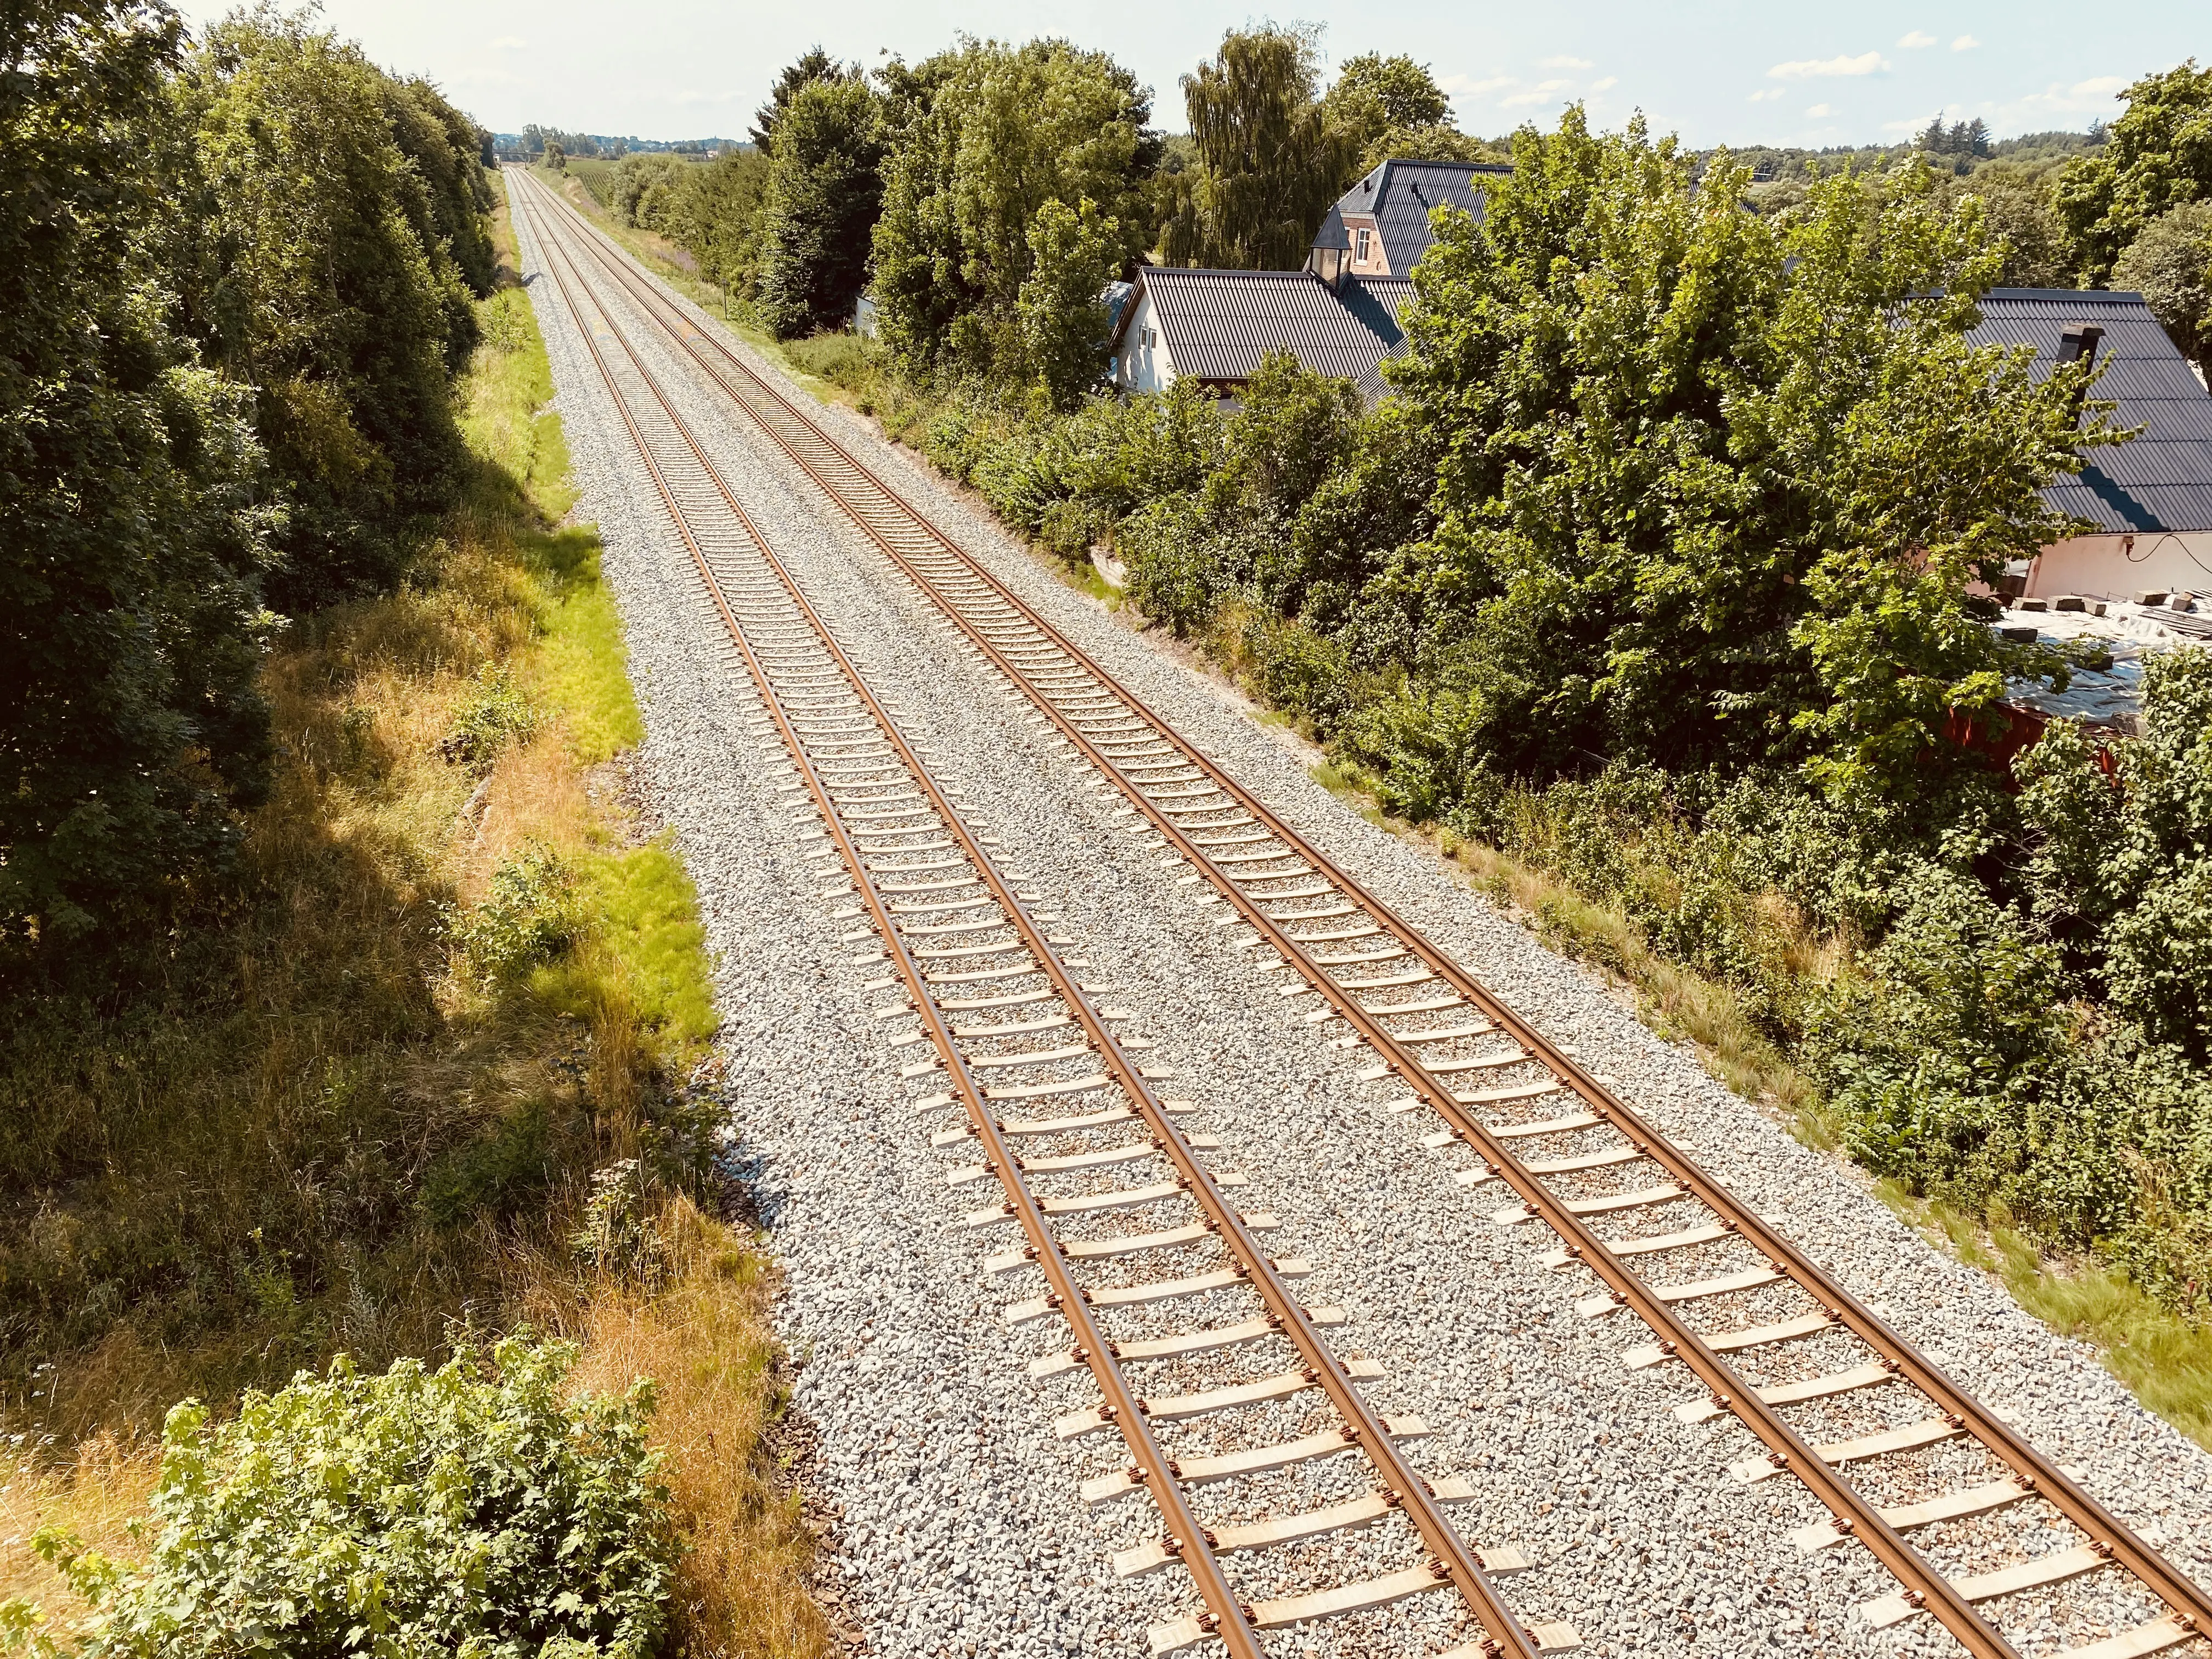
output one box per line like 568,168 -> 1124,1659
1966,287 -> 2212,600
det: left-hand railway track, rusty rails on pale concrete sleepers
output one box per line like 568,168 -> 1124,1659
517,186 -> 1575,1659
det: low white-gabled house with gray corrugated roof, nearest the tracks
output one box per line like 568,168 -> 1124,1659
1110,266 -> 1404,403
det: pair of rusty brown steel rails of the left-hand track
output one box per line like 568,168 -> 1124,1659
531,182 -> 1537,1659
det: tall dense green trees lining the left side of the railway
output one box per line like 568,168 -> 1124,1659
0,0 -> 495,967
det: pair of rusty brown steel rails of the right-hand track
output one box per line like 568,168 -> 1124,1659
522,172 -> 2212,1659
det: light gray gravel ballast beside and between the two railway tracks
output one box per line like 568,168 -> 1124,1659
517,188 -> 2212,1657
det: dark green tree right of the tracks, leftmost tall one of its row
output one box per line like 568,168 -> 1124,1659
759,80 -> 883,338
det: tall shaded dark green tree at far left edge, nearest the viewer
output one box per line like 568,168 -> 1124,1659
0,0 -> 270,946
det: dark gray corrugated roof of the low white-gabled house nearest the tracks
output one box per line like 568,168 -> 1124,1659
1115,266 -> 1398,391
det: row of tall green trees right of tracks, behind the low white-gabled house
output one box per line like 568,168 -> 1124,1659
584,26 -> 1493,393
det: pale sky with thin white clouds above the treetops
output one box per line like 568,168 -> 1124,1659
186,0 -> 2212,146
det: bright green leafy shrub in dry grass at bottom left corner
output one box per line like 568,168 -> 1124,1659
40,1336 -> 677,1659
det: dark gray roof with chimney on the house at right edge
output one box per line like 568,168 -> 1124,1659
1966,287 -> 2212,531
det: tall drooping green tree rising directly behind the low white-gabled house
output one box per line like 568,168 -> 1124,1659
1161,24 -> 1363,270
